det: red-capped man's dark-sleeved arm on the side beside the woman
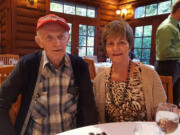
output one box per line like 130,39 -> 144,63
76,59 -> 98,126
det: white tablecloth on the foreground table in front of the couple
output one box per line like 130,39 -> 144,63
57,122 -> 180,135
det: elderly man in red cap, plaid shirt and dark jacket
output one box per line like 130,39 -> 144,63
0,14 -> 97,135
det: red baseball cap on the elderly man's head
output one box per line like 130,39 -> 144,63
36,14 -> 70,31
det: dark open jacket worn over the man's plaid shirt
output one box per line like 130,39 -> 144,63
0,51 -> 97,135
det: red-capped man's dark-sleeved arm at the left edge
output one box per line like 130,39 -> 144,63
0,63 -> 23,135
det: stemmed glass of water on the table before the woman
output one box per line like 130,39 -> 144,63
156,103 -> 179,135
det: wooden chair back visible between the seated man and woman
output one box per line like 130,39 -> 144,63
84,58 -> 96,80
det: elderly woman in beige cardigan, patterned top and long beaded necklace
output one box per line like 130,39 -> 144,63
94,20 -> 166,123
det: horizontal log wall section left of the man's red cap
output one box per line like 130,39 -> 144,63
12,0 -> 46,56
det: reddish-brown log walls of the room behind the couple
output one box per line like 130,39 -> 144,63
0,0 -> 167,63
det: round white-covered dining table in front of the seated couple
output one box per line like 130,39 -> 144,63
56,122 -> 180,135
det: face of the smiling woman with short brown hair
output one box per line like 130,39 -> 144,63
106,35 -> 130,63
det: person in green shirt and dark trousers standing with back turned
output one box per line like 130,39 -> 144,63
155,0 -> 180,104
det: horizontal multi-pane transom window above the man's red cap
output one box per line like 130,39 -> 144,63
50,0 -> 96,18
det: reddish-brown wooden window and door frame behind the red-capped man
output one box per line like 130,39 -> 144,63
46,0 -> 99,55
